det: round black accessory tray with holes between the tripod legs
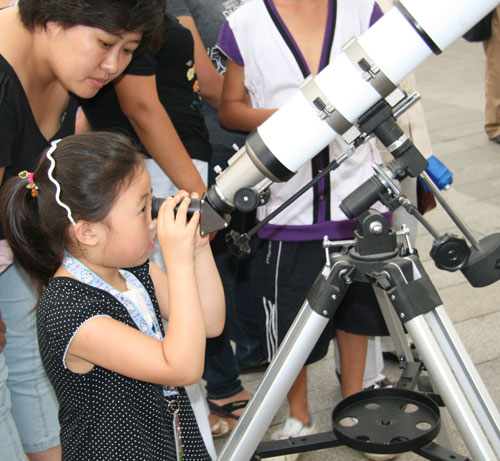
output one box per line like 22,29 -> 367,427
332,389 -> 441,454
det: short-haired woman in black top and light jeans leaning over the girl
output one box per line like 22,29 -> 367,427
0,0 -> 165,461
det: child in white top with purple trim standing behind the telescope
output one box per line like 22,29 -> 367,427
218,0 -> 387,461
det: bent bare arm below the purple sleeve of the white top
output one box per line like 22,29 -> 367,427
219,59 -> 276,131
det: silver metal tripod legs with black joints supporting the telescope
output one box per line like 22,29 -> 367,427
219,210 -> 500,461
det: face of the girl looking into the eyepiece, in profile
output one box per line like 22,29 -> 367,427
104,167 -> 156,267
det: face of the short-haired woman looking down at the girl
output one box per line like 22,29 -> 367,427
47,22 -> 142,98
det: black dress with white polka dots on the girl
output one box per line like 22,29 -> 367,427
37,262 -> 210,461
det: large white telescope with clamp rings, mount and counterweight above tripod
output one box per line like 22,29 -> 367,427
195,0 -> 500,286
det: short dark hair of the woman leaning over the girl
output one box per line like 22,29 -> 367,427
18,0 -> 165,48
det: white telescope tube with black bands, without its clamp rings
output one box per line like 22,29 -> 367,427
208,0 -> 498,221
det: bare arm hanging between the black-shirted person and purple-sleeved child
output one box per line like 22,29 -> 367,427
177,16 -> 223,108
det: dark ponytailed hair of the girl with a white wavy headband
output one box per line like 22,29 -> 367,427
0,132 -> 144,295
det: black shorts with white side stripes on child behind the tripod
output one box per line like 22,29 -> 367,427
255,240 -> 388,364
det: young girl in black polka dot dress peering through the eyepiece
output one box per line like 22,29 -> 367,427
0,132 -> 225,460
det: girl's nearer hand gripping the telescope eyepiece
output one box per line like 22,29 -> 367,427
157,191 -> 200,265
